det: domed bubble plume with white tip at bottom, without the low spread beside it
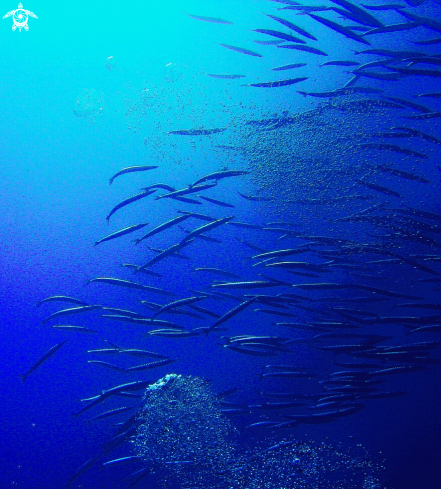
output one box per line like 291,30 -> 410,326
135,374 -> 235,487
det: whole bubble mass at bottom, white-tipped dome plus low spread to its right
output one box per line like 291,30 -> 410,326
134,374 -> 385,489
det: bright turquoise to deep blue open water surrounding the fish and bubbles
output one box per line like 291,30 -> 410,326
0,0 -> 441,489
